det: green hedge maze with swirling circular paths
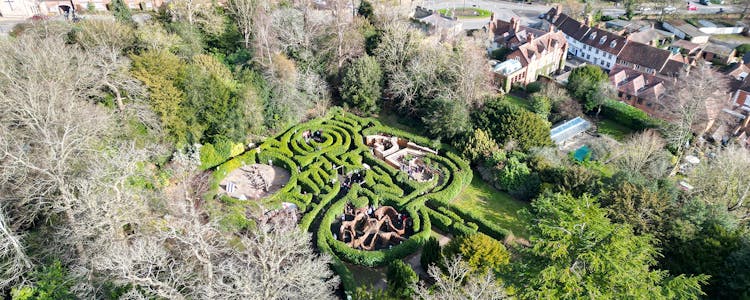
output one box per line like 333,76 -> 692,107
214,110 -> 507,290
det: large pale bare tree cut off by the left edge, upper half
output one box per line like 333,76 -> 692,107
0,32 -> 111,232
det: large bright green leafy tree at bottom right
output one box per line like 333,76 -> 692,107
515,194 -> 707,299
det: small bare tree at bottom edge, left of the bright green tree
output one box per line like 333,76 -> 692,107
414,256 -> 508,300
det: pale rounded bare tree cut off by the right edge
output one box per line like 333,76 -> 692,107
690,145 -> 750,221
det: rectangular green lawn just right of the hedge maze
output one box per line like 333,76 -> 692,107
453,171 -> 529,239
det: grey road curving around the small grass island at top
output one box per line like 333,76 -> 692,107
420,0 -> 551,29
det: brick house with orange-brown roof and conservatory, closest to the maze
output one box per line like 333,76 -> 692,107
489,14 -> 568,92
